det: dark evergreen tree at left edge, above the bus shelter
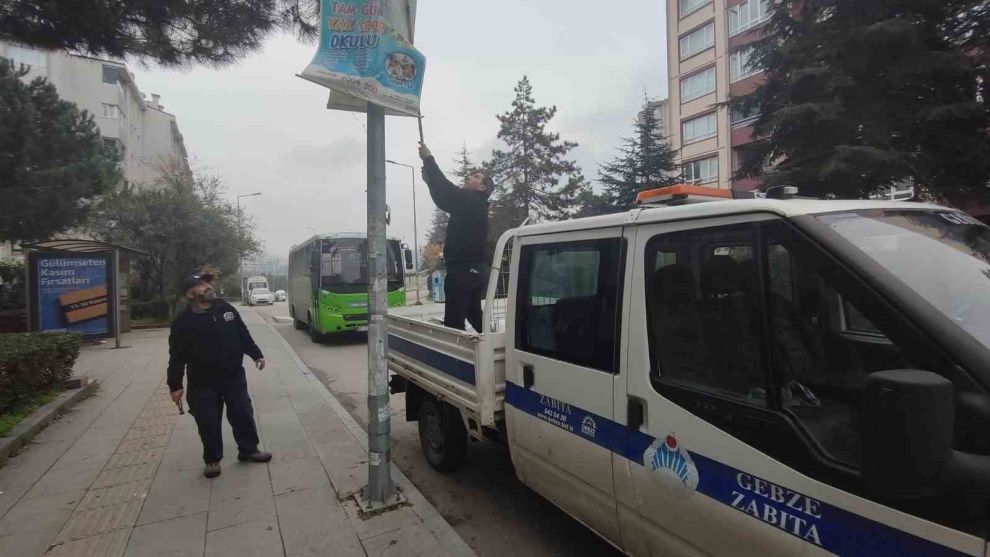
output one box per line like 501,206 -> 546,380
0,58 -> 121,240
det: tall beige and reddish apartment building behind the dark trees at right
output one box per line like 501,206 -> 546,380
667,0 -> 770,191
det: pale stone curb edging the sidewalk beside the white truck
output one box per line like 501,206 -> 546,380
262,312 -> 475,557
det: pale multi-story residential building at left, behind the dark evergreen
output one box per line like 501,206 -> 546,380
0,41 -> 189,185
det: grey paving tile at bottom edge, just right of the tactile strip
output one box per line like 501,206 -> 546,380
127,512 -> 207,557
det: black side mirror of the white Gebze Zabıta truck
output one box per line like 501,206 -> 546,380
862,369 -> 990,500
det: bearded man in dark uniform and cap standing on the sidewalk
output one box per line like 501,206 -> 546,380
168,275 -> 272,478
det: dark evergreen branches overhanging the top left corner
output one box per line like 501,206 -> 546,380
0,0 -> 320,66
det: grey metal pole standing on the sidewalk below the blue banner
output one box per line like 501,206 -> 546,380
363,103 -> 396,508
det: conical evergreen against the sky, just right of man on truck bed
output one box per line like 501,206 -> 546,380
485,76 -> 587,237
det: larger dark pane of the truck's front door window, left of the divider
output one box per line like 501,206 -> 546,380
646,225 -> 766,406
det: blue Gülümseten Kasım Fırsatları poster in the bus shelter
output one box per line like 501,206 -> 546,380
31,252 -> 112,336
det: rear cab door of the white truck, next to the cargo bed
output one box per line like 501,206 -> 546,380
506,228 -> 625,544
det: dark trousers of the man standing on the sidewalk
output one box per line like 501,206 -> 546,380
186,374 -> 258,463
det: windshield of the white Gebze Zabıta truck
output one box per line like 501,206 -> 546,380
817,209 -> 990,348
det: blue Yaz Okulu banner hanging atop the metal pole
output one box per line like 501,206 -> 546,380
299,0 -> 426,116
